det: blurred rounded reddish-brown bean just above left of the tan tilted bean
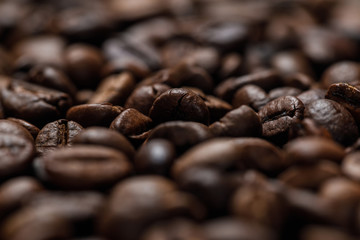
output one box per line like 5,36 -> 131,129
64,44 -> 103,88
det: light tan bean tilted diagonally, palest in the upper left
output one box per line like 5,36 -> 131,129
88,72 -> 135,105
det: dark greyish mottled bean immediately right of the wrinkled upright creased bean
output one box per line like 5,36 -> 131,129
306,99 -> 359,145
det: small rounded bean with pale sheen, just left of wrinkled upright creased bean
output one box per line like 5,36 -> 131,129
232,84 -> 270,111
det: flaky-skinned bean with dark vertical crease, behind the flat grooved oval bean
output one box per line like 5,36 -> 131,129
35,119 -> 83,153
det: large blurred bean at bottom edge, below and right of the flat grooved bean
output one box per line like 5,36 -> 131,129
100,176 -> 204,240
